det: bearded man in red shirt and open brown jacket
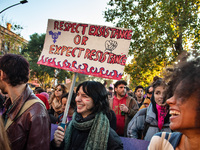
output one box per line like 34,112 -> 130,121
109,80 -> 138,136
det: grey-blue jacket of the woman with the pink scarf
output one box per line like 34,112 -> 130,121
127,95 -> 171,141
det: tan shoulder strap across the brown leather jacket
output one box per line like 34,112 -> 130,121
5,99 -> 44,130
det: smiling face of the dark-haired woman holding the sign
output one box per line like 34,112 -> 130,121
75,86 -> 94,118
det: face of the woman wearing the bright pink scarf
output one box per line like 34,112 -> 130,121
154,86 -> 165,105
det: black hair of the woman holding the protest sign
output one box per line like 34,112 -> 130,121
76,81 -> 110,114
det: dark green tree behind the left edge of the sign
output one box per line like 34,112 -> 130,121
22,33 -> 72,88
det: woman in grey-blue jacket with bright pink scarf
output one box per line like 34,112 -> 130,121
127,79 -> 171,141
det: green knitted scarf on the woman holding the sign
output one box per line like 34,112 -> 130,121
64,112 -> 110,150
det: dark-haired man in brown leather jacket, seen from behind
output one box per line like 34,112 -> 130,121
0,54 -> 50,150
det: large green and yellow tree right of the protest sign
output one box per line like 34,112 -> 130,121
104,0 -> 200,85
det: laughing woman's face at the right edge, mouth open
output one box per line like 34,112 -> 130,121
167,84 -> 200,133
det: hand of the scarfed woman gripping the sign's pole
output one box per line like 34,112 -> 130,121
54,126 -> 65,147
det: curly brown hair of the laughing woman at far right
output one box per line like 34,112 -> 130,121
165,58 -> 200,125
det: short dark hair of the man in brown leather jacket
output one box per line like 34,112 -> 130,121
0,54 -> 29,86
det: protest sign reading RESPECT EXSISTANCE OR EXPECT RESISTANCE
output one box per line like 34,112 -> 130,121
37,19 -> 132,80
